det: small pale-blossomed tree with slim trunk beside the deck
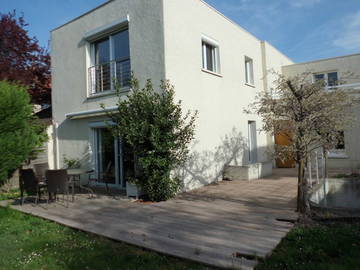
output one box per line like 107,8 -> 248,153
247,73 -> 352,213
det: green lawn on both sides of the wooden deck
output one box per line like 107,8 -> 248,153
0,207 -> 360,270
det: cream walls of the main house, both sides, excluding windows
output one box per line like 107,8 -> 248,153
52,0 -> 292,190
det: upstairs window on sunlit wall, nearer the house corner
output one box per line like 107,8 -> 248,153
202,40 -> 220,73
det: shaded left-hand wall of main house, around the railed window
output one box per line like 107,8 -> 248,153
51,0 -> 164,167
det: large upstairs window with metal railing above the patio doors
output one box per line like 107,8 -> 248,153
89,29 -> 131,95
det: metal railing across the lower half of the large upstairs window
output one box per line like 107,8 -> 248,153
88,59 -> 131,95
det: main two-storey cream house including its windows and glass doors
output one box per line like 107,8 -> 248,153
51,0 -> 293,190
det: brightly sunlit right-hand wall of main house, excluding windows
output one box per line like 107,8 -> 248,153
164,0 -> 292,189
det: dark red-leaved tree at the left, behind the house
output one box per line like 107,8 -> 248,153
0,11 -> 51,104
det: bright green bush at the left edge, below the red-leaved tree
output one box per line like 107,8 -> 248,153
0,81 -> 47,186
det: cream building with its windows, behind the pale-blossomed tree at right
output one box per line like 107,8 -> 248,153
282,54 -> 360,169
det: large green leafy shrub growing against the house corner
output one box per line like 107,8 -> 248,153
104,79 -> 197,201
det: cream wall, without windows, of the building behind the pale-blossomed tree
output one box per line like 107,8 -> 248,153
283,54 -> 360,169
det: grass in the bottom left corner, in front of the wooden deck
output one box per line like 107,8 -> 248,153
0,207 -> 209,270
